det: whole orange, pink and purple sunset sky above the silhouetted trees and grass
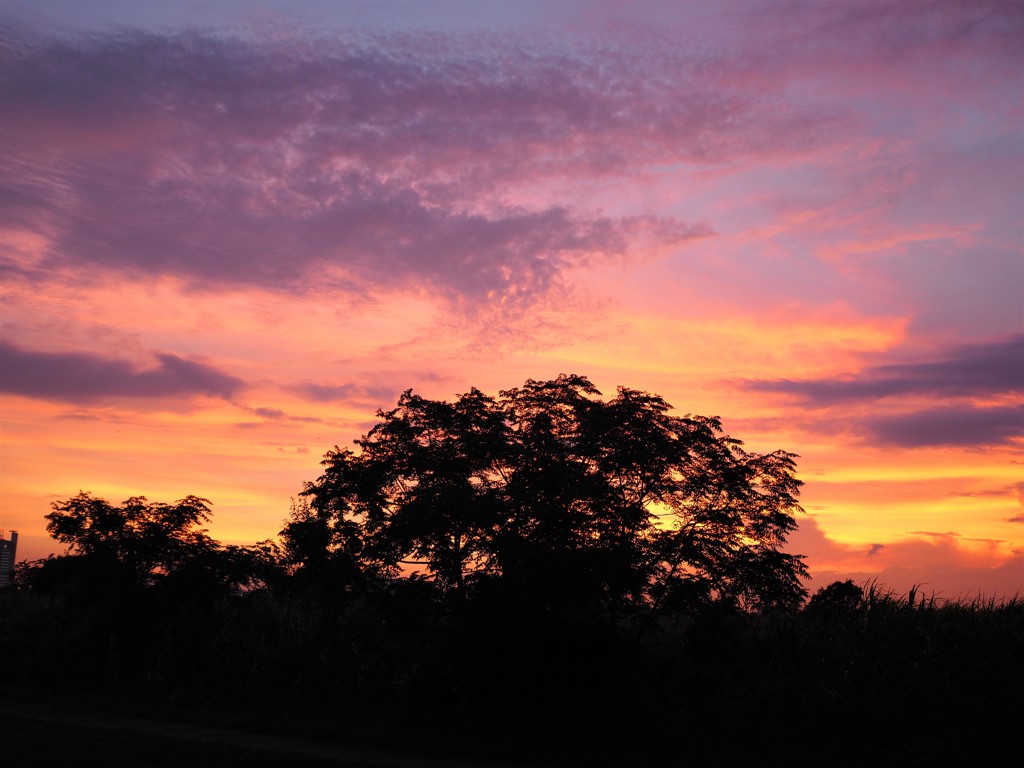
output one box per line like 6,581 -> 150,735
0,0 -> 1024,597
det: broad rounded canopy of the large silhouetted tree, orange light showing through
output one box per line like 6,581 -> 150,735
290,375 -> 806,616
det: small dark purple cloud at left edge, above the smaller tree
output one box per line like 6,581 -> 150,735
0,342 -> 244,403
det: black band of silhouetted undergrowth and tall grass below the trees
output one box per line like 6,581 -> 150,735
0,580 -> 1024,766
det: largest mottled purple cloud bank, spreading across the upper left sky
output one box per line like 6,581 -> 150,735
0,25 -> 790,306
